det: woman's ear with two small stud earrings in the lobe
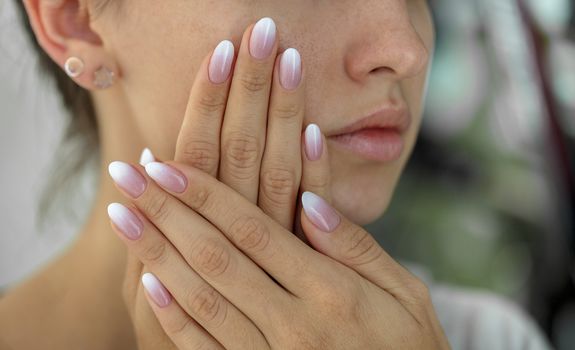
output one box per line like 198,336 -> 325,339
24,0 -> 119,90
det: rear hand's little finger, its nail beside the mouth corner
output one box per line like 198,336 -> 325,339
294,124 -> 331,244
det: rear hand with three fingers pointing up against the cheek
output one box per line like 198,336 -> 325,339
118,19 -> 329,349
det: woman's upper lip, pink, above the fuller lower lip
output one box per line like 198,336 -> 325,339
329,103 -> 411,136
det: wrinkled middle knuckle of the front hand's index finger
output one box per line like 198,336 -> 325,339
229,216 -> 270,253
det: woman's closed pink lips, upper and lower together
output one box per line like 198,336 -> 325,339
328,104 -> 411,162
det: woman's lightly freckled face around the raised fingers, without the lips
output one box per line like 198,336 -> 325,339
94,0 -> 434,225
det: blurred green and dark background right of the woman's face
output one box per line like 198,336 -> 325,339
367,0 -> 575,349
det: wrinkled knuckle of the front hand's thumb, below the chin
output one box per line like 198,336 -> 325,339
342,227 -> 383,266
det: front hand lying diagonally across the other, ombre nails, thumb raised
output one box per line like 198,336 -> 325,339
107,162 -> 449,349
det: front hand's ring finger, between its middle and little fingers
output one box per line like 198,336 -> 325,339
108,201 -> 264,347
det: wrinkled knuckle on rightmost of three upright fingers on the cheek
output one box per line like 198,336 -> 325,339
260,168 -> 296,207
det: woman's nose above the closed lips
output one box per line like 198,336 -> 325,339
345,0 -> 429,81
